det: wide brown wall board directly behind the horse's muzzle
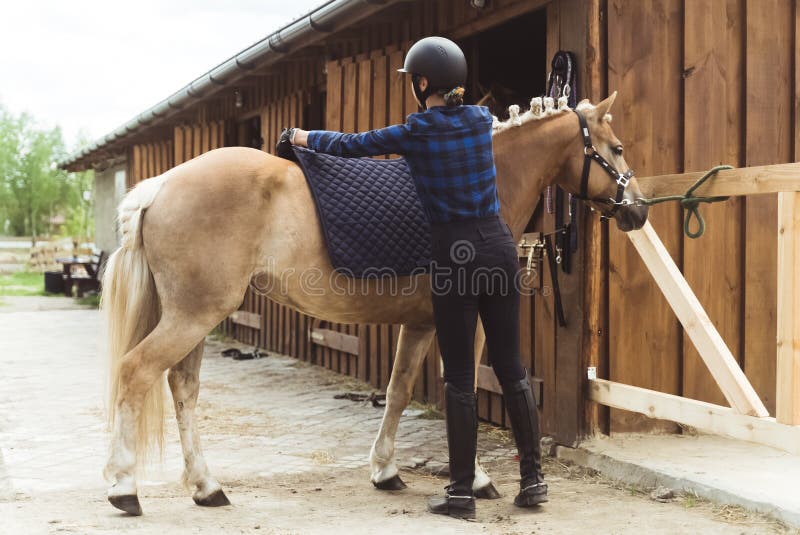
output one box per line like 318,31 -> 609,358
608,0 -> 683,431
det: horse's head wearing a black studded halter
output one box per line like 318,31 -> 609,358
556,92 -> 648,232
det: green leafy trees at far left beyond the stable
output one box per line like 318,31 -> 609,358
0,105 -> 94,241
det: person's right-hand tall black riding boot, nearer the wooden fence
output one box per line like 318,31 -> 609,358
502,373 -> 547,507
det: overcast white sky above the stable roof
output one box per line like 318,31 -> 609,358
0,0 -> 324,147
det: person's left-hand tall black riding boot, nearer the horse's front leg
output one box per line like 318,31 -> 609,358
428,383 -> 478,518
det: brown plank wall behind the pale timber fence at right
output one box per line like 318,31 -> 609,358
606,0 -> 800,431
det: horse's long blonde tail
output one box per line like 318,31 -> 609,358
100,175 -> 170,462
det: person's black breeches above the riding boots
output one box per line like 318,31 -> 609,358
431,216 -> 525,392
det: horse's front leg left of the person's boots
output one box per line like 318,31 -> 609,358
369,324 -> 436,490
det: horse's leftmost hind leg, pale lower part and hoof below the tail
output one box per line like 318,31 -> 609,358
105,314 -> 215,515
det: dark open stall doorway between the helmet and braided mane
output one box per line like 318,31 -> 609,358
463,9 -> 549,119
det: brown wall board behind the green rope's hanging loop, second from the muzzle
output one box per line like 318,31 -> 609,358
683,0 -> 744,405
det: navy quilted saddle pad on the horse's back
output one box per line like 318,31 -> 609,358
293,147 -> 431,278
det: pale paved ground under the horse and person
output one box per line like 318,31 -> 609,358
0,298 -> 785,535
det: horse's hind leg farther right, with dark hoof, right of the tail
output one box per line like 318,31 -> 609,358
167,342 -> 230,507
